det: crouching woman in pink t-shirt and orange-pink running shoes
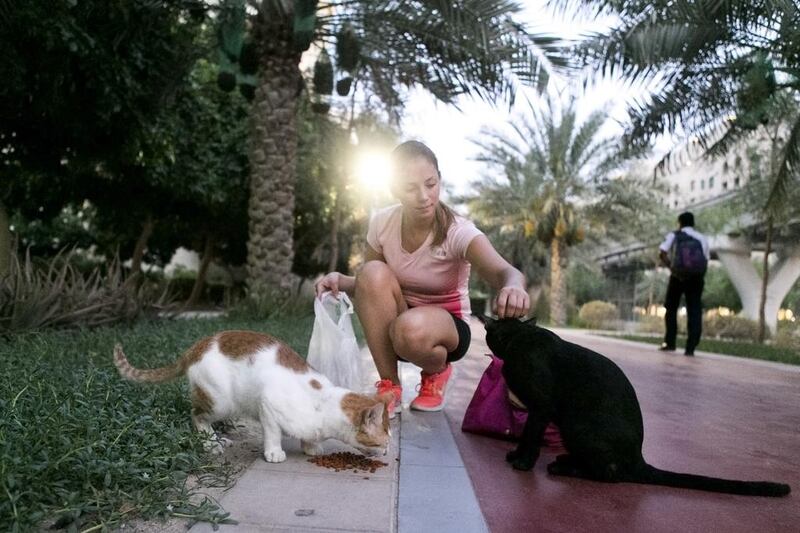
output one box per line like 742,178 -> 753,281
315,141 -> 530,417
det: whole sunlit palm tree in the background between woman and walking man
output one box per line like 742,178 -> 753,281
471,98 -> 619,326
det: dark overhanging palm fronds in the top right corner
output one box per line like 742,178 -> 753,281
554,0 -> 800,208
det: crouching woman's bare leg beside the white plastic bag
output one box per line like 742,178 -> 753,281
355,261 -> 408,385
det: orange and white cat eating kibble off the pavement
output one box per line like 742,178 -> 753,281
114,331 -> 389,463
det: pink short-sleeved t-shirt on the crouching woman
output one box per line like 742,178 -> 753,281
367,204 -> 483,318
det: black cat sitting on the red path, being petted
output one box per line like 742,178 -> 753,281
484,317 -> 791,496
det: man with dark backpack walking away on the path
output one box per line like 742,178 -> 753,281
659,211 -> 711,356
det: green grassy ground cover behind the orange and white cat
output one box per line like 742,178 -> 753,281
0,314 -> 313,532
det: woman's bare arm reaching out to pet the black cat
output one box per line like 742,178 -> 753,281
467,235 -> 531,318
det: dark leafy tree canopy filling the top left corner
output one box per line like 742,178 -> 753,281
0,0 -> 202,213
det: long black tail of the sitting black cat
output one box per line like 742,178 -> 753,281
631,464 -> 791,497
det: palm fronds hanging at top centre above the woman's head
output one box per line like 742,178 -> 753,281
348,0 -> 566,109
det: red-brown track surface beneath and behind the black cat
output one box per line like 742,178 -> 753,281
445,321 -> 800,533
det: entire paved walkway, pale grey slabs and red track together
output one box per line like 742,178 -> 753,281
191,322 -> 800,533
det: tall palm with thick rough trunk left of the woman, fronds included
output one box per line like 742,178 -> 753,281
220,0 -> 564,294
